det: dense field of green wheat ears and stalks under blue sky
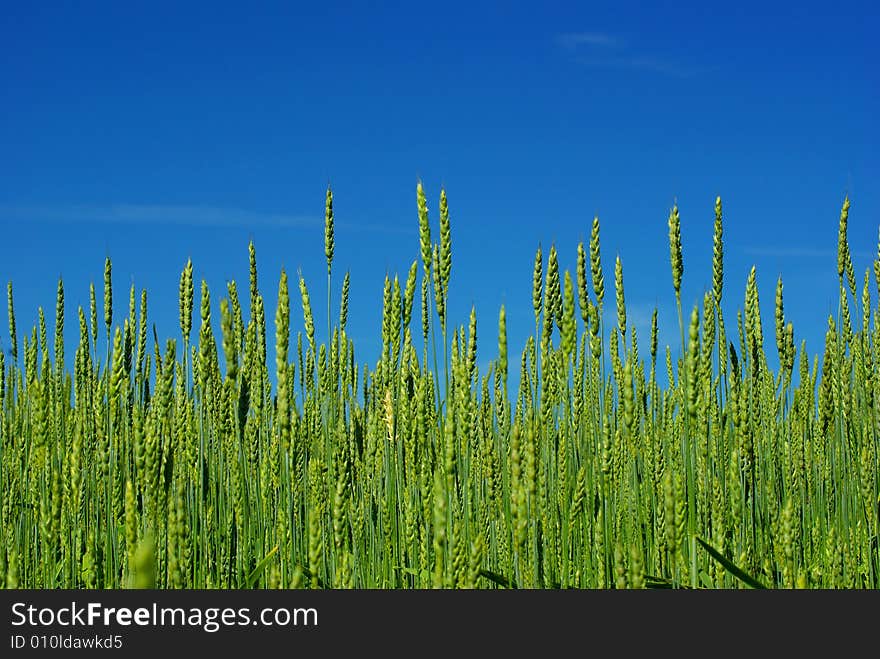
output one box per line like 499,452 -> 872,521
0,185 -> 880,588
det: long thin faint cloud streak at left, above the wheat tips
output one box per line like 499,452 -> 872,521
0,204 -> 415,234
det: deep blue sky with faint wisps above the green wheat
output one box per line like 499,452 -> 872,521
0,1 -> 880,384
